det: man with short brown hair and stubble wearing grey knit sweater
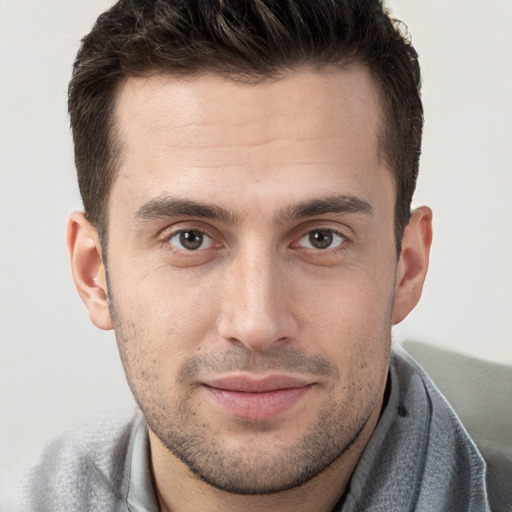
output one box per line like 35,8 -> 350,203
13,0 -> 488,512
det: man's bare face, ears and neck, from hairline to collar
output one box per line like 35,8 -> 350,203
68,65 -> 431,512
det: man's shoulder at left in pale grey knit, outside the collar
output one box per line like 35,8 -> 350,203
1,412 -> 140,512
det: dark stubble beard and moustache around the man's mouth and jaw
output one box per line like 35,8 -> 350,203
109,276 -> 391,495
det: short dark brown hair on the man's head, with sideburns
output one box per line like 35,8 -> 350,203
69,0 -> 423,249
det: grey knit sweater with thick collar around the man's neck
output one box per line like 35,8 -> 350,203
0,348 -> 490,512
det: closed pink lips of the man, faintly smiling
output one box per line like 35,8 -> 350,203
203,375 -> 314,421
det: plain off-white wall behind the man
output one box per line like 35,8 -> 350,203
0,0 -> 512,467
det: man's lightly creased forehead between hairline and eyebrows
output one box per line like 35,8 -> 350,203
111,64 -> 390,216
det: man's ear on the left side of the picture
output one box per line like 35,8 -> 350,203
66,212 -> 112,330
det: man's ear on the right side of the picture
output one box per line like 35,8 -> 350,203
393,206 -> 432,325
